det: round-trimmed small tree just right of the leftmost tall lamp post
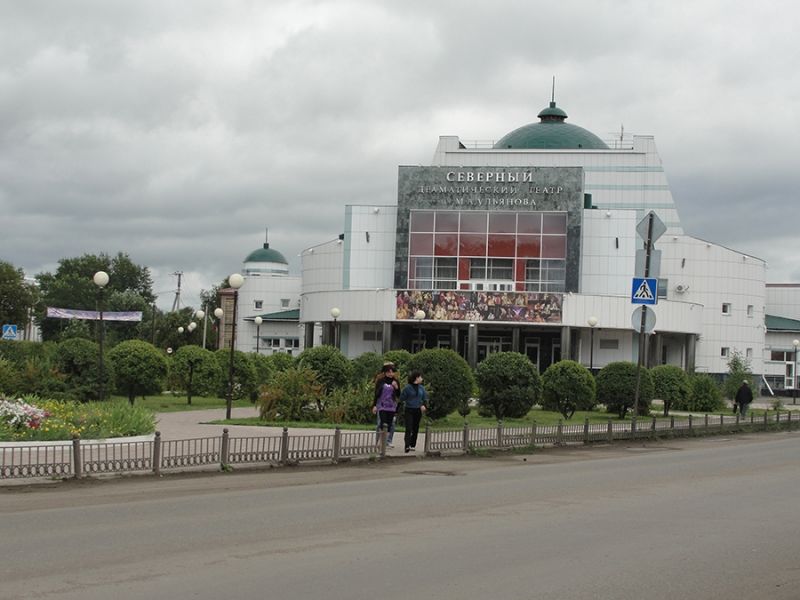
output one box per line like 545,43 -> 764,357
108,340 -> 168,406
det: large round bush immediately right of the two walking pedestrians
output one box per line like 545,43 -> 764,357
406,348 -> 475,419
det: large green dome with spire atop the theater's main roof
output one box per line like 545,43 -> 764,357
494,102 -> 608,150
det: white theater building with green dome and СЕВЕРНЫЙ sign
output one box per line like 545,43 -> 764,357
231,102 -> 800,388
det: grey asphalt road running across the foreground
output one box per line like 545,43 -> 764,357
0,433 -> 800,600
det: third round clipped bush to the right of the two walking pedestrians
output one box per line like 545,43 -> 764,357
542,360 -> 596,419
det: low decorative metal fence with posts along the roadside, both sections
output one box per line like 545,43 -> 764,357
0,412 -> 800,479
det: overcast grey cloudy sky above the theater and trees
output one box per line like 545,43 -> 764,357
0,0 -> 800,307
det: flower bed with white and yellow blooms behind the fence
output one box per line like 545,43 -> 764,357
0,396 -> 156,441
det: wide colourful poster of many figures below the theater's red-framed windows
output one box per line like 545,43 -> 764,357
397,290 -> 563,323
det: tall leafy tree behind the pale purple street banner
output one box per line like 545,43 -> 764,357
35,252 -> 155,343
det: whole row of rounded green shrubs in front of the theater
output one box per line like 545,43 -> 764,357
0,339 -> 723,423
